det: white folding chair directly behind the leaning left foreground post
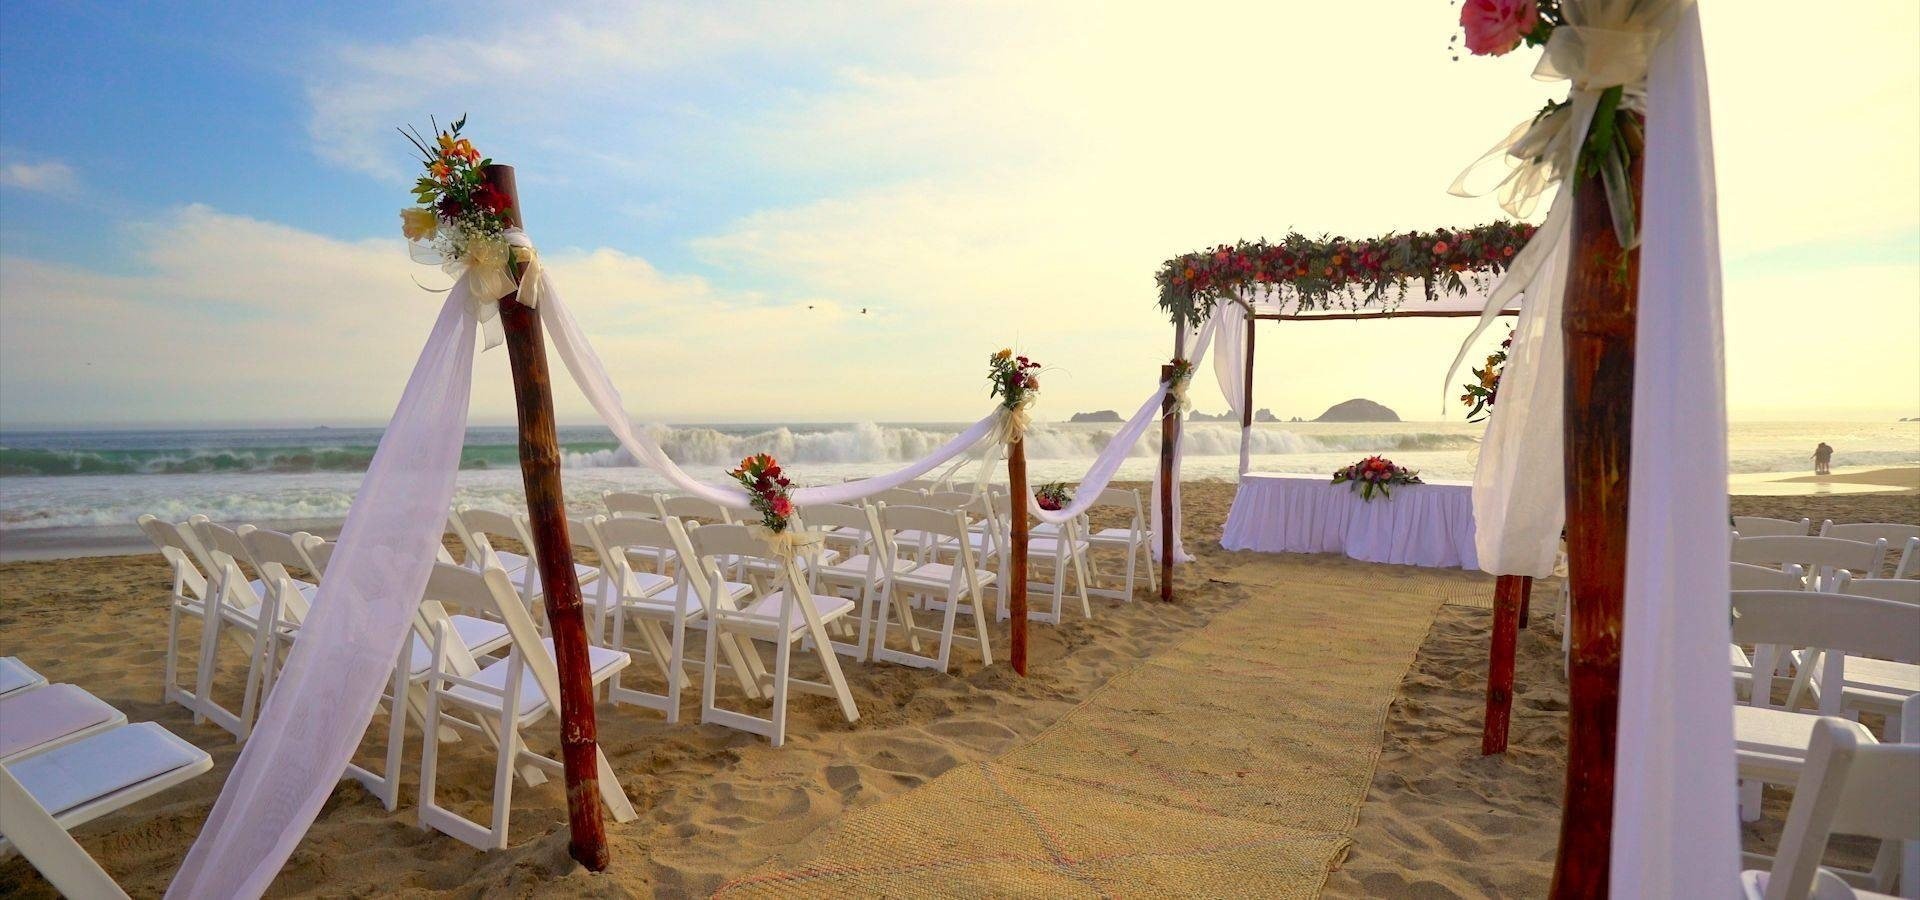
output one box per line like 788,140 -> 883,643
419,562 -> 637,850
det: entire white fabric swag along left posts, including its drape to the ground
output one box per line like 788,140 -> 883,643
167,230 -> 1212,898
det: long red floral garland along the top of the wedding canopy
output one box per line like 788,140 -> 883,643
1154,221 -> 1534,326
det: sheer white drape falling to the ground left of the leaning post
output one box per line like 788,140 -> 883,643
167,291 -> 476,898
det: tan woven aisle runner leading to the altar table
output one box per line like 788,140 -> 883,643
716,578 -> 1446,898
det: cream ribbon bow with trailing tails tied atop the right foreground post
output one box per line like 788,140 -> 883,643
1440,0 -> 1693,402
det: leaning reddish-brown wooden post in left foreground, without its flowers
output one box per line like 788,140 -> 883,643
486,165 -> 607,871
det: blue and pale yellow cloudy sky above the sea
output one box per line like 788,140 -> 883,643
0,0 -> 1920,430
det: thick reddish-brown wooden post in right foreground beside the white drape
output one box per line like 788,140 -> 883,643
1551,129 -> 1642,900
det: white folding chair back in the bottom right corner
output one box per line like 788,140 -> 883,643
1766,718 -> 1920,900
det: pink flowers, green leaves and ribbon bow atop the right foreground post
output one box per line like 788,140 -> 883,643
1453,0 -> 1651,249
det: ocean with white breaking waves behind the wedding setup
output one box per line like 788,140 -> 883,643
0,422 -> 1920,558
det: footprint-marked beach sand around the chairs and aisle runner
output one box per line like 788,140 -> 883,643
0,484 -> 1920,896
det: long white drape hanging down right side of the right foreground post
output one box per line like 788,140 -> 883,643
1612,4 -> 1740,896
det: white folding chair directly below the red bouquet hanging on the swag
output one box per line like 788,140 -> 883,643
687,526 -> 860,746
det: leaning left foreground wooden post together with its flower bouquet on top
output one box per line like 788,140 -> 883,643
401,115 -> 609,871
